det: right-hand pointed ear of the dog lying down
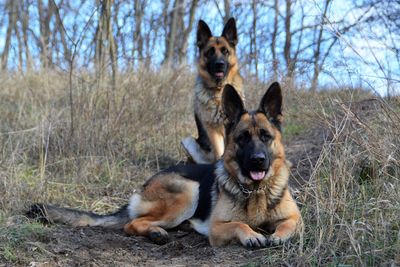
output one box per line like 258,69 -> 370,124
258,82 -> 282,130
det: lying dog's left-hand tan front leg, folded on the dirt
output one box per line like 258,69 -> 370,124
209,222 -> 267,247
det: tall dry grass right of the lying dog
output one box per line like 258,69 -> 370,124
301,98 -> 400,266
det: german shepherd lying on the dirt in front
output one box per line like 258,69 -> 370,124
28,83 -> 302,247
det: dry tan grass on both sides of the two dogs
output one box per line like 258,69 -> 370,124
0,69 -> 400,265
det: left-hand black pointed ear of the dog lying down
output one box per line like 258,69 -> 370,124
222,84 -> 245,125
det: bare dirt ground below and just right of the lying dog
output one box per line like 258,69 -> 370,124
0,130 -> 324,266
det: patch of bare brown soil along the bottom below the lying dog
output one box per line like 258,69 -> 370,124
19,226 -> 288,266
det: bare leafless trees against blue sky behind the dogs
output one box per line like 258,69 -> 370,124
0,0 -> 400,95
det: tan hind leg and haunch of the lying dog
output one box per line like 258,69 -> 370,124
124,175 -> 199,244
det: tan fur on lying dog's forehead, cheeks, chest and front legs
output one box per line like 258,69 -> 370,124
210,114 -> 302,246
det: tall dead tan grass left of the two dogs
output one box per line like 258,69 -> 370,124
0,70 -> 194,212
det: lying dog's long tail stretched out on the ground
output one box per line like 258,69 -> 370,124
27,204 -> 130,229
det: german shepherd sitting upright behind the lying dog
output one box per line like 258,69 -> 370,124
182,18 -> 243,163
